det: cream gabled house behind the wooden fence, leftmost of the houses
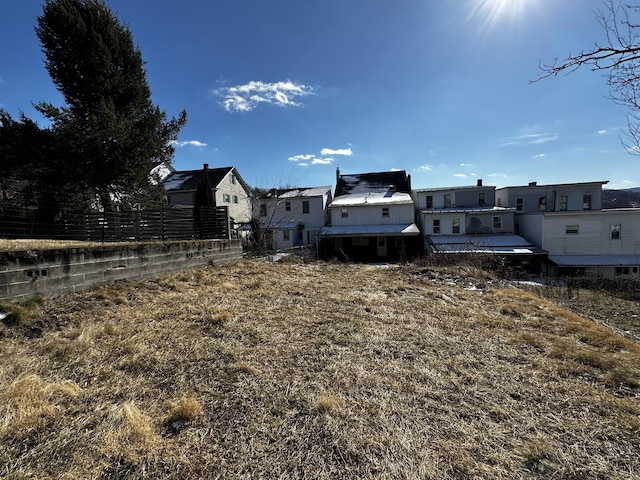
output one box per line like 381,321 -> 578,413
159,163 -> 251,229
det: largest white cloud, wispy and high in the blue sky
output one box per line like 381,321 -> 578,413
214,80 -> 313,112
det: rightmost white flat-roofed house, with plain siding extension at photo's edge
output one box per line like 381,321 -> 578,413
496,181 -> 640,278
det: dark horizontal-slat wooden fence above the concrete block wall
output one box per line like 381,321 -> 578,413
0,206 -> 231,242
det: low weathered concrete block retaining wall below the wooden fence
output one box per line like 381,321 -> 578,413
0,240 -> 242,300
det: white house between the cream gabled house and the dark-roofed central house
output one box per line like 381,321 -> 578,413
253,186 -> 332,249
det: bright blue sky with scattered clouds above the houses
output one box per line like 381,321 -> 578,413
0,0 -> 640,188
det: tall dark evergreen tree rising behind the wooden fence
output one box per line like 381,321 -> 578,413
35,0 -> 186,210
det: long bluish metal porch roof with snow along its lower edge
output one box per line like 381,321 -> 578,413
427,235 -> 546,255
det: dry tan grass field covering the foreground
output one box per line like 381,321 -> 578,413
0,261 -> 640,480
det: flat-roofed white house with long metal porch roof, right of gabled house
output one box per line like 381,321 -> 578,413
413,180 -> 544,269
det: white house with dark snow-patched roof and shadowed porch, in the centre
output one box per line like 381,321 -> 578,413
318,169 -> 420,261
